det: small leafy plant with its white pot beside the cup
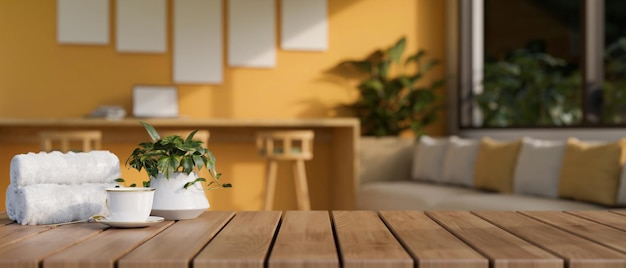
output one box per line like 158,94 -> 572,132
126,122 -> 231,220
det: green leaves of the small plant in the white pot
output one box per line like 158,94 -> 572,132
122,122 -> 232,189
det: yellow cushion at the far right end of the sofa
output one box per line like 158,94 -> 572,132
559,138 -> 626,206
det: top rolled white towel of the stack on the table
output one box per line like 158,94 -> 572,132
10,151 -> 120,186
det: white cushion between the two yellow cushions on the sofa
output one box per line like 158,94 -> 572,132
513,137 -> 565,198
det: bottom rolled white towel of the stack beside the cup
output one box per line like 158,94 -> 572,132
6,183 -> 115,225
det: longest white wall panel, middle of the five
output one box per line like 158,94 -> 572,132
173,0 -> 223,84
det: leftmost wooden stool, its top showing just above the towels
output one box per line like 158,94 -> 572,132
39,130 -> 102,153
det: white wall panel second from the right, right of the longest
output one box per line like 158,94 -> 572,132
227,0 -> 276,68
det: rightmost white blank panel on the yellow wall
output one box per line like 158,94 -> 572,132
280,0 -> 328,51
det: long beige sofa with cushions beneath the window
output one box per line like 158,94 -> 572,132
356,137 -> 626,210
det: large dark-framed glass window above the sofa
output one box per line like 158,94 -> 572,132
455,0 -> 626,129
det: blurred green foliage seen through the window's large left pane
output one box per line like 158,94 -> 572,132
474,48 -> 582,127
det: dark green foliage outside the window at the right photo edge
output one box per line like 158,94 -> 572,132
602,38 -> 626,124
